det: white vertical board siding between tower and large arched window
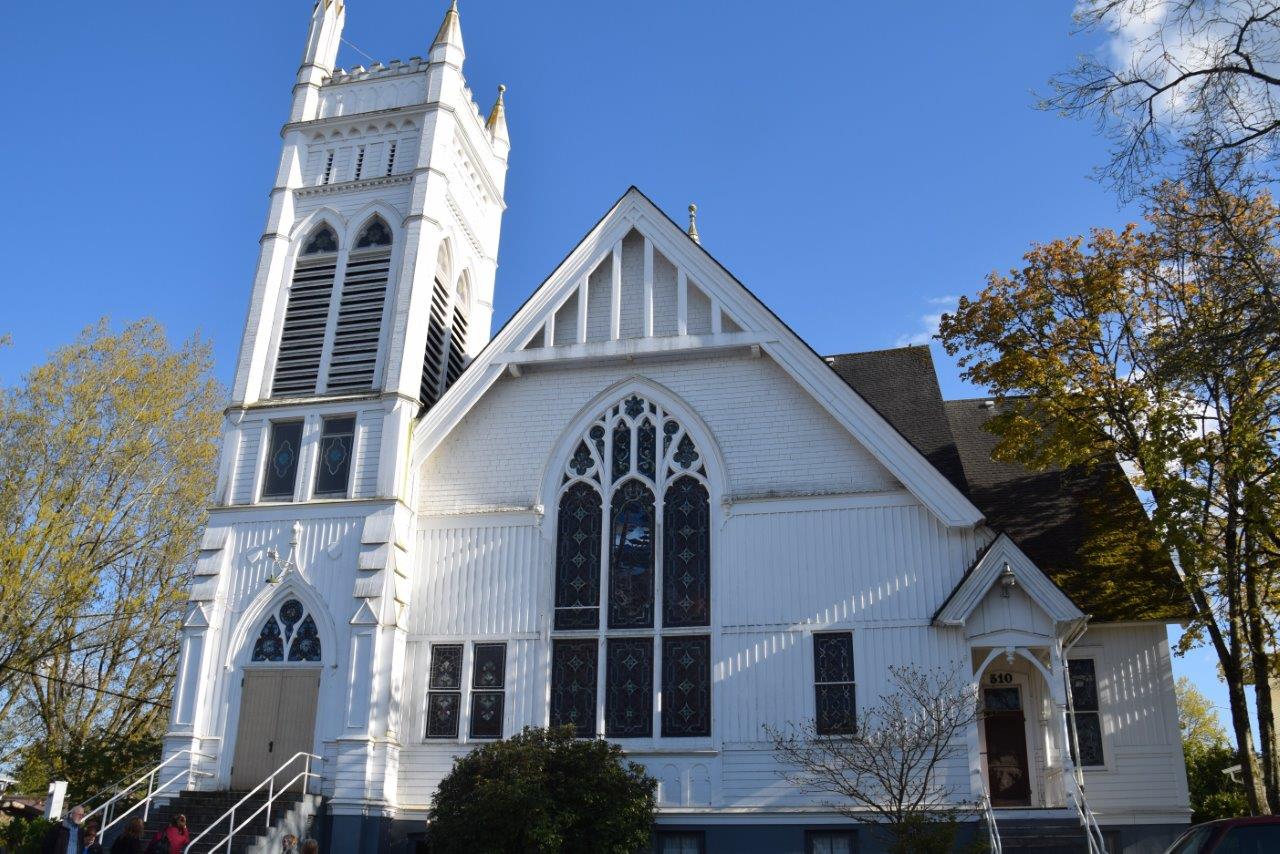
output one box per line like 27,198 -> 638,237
408,525 -> 541,635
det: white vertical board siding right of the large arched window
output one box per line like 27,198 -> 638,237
717,506 -> 972,626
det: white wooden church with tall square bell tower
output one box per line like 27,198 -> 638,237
157,0 -> 1190,854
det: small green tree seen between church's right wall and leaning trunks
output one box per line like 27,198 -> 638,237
1176,676 -> 1249,822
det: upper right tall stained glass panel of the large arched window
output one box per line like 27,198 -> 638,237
662,476 -> 712,626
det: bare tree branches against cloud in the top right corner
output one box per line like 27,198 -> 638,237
1043,0 -> 1280,189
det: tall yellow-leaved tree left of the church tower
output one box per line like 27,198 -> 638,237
0,320 -> 221,804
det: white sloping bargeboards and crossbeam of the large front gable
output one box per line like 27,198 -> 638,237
413,187 -> 982,528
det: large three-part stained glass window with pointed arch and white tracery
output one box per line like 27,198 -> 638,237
550,394 -> 712,737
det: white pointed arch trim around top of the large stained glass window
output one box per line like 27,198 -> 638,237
540,376 -> 728,508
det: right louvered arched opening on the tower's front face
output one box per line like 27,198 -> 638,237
325,216 -> 392,394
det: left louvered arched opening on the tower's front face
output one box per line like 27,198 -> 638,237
271,228 -> 338,397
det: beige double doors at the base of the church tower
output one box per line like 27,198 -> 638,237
232,667 -> 320,791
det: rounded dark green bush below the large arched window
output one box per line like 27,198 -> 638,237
428,726 -> 658,854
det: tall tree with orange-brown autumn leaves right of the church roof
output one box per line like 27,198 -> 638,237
941,172 -> 1280,812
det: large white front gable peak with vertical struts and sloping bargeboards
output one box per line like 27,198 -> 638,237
413,187 -> 982,528
